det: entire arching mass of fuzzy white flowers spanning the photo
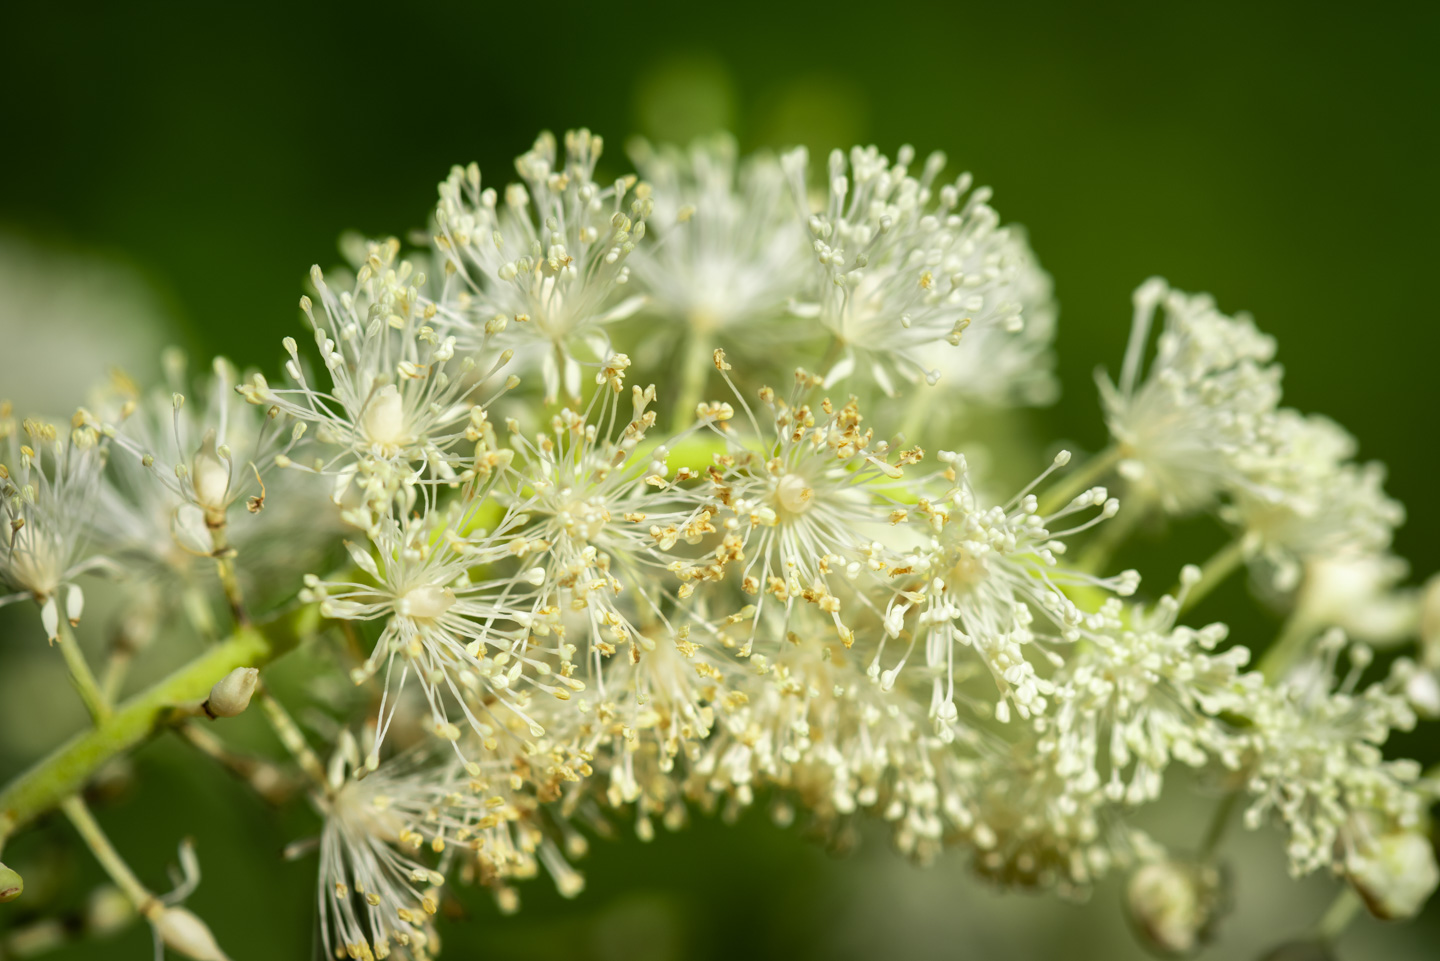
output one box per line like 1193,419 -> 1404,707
0,131 -> 1440,960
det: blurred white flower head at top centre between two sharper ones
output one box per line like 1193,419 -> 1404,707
629,134 -> 809,338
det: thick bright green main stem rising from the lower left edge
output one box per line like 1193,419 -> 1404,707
0,608 -> 306,839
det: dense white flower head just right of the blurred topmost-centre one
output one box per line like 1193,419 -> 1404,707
782,147 -> 1024,395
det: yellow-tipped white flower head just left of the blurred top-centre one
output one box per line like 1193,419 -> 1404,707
433,130 -> 651,399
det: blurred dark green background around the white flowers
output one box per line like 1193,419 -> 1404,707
0,0 -> 1440,961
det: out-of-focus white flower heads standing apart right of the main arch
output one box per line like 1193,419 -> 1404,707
1100,278 -> 1404,591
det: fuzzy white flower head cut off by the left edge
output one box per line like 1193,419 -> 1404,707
0,402 -> 109,640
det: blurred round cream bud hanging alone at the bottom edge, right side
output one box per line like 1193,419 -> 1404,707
1125,860 -> 1221,957
